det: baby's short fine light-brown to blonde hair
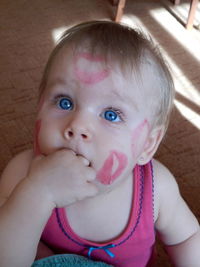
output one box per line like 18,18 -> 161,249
40,21 -> 174,131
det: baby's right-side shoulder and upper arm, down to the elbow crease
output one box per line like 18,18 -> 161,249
153,160 -> 199,245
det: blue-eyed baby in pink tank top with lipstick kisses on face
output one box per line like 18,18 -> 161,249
0,21 -> 200,267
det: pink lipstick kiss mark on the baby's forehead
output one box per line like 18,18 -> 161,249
74,52 -> 110,85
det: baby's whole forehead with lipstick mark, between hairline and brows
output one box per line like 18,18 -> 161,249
47,47 -> 153,107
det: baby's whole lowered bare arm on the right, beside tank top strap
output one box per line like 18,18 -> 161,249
154,162 -> 200,267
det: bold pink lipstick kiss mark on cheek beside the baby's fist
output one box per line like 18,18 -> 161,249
97,151 -> 128,185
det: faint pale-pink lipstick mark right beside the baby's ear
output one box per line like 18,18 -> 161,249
131,119 -> 149,157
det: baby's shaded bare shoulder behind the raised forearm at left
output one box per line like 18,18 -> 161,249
0,150 -> 33,205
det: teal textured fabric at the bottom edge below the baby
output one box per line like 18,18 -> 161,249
31,254 -> 112,267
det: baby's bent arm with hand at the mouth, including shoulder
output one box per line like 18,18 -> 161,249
0,149 -> 97,267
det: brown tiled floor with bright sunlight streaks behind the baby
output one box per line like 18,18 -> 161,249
0,0 -> 200,266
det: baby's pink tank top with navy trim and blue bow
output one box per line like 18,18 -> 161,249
42,162 -> 155,267
